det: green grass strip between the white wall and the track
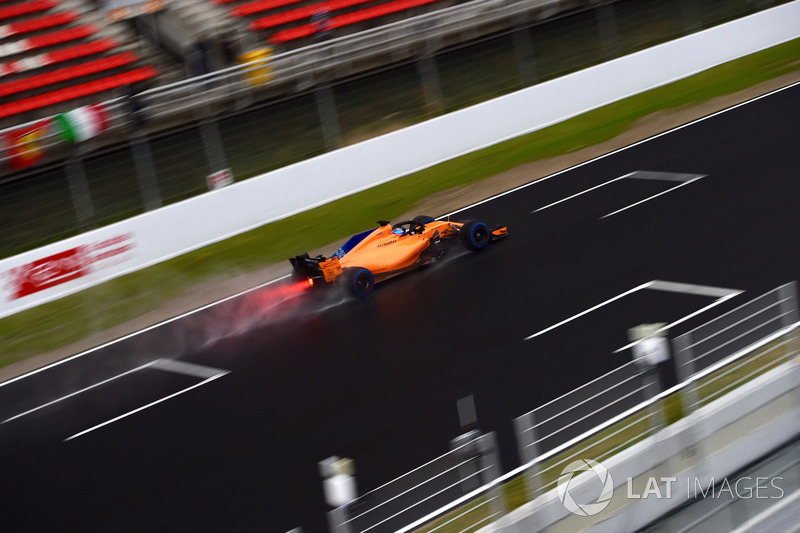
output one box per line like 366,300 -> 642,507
0,39 -> 800,366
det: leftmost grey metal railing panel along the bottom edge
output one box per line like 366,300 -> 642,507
328,433 -> 502,533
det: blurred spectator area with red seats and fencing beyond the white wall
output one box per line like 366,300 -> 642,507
0,0 -> 785,257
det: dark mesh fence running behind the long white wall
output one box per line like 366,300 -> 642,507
0,0 -> 784,257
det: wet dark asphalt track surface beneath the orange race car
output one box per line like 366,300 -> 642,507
0,82 -> 800,532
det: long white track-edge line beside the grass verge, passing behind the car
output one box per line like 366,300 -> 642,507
0,82 -> 800,387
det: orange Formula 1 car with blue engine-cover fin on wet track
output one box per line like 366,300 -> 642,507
289,216 -> 508,298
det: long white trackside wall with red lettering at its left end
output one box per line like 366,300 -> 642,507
0,1 -> 800,318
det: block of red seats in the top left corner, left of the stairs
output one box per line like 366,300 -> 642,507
0,0 -> 184,125
